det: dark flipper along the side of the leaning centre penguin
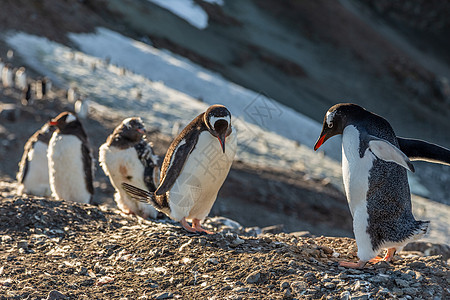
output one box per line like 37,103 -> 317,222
155,139 -> 196,196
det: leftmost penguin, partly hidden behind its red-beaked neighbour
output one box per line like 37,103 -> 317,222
17,122 -> 55,197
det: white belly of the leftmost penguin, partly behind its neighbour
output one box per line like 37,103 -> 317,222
22,141 -> 51,196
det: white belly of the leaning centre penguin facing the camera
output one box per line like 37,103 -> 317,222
169,130 -> 237,221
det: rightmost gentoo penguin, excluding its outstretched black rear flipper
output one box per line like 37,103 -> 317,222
314,103 -> 429,268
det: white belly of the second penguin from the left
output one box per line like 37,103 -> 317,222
48,133 -> 91,203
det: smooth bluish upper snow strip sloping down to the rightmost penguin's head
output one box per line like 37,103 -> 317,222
69,28 -> 340,160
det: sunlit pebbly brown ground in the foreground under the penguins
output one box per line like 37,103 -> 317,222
0,182 -> 450,299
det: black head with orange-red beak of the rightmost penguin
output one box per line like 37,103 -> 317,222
314,103 -> 367,150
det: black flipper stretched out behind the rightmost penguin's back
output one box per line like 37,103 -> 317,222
397,137 -> 450,166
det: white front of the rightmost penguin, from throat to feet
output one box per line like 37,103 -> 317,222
342,126 -> 376,260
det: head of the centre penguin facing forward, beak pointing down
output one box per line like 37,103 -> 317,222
204,104 -> 231,153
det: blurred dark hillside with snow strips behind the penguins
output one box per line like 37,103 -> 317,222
0,0 -> 450,243
